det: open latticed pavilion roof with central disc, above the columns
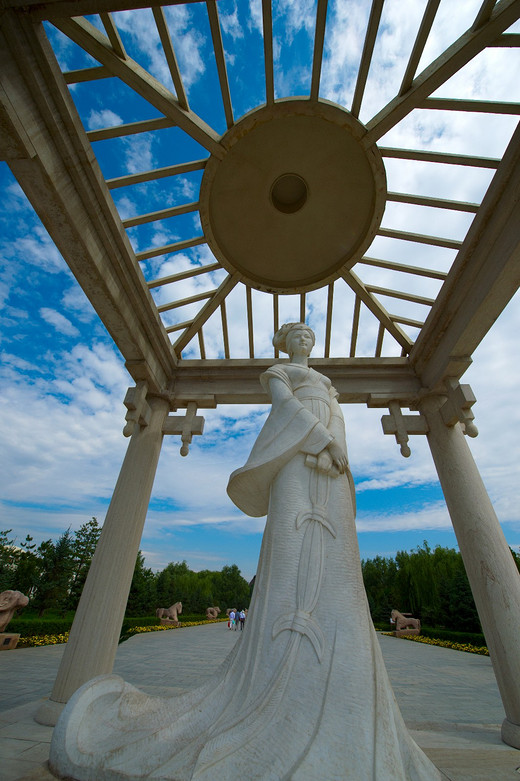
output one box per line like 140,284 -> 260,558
1,0 -> 520,406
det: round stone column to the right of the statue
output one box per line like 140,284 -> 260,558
420,396 -> 520,749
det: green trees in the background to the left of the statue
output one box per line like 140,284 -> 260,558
0,518 -> 250,616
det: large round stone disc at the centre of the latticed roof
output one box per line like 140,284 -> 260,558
200,99 -> 386,293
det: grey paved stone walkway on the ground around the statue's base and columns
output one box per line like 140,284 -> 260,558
0,623 -> 520,781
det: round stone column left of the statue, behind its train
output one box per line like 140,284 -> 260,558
36,397 -> 169,725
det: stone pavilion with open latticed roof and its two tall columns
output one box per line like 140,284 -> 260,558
4,0 -> 520,748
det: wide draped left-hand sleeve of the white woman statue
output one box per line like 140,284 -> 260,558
227,365 -> 334,517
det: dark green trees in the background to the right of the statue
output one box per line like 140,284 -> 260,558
362,542 -> 520,632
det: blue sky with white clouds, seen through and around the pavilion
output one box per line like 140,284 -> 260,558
0,0 -> 520,578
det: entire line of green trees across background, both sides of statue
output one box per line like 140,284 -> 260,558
0,518 -> 520,632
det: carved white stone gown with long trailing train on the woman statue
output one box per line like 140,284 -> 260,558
51,364 -> 441,781
